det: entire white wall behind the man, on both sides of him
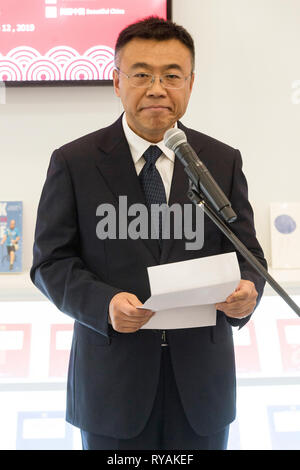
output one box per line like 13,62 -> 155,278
0,0 -> 300,270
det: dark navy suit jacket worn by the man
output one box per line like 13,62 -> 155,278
30,114 -> 266,438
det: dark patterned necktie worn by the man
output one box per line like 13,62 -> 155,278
139,145 -> 167,240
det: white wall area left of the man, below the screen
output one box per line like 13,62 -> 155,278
0,86 -> 121,271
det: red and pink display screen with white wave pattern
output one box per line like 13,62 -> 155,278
0,0 -> 170,84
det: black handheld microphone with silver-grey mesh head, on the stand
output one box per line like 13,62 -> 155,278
164,128 -> 237,223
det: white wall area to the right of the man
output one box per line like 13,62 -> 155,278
174,0 -> 300,261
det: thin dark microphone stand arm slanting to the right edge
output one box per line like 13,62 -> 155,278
185,178 -> 300,317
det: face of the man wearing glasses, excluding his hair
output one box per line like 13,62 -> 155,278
114,39 -> 194,142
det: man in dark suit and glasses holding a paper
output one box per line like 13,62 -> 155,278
31,18 -> 266,450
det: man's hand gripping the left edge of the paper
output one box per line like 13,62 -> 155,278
109,292 -> 155,333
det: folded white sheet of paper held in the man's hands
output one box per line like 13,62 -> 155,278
139,252 -> 241,330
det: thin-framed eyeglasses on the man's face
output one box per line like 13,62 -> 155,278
116,67 -> 192,90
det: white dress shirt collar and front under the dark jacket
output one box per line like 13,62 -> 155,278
122,113 -> 177,202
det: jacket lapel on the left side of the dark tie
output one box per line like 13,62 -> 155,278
96,117 -> 160,263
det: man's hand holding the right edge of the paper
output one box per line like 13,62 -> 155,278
216,279 -> 258,318
